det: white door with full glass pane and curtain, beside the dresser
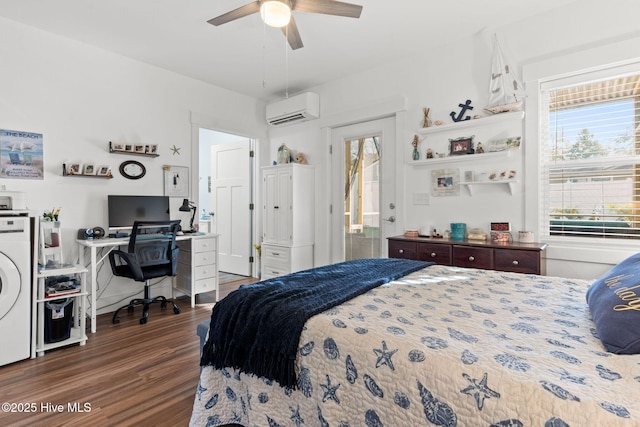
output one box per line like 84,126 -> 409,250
331,117 -> 397,262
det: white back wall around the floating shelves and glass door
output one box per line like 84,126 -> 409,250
269,0 -> 640,278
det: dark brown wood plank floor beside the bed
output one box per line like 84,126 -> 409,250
0,279 -> 256,427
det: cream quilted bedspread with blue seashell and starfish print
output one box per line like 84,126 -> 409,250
191,266 -> 640,427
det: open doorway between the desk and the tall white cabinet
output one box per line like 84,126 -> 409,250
199,128 -> 255,276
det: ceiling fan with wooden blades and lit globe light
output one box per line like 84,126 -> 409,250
207,0 -> 362,50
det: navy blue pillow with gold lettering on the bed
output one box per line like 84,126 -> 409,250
587,253 -> 640,354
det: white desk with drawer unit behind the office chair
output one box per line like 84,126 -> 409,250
76,234 -> 219,333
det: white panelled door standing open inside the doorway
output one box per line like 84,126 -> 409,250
211,141 -> 251,276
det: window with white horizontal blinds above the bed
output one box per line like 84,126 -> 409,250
540,68 -> 640,239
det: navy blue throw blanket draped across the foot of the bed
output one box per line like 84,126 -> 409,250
200,258 -> 433,388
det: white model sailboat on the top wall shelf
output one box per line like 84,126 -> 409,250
485,36 -> 527,114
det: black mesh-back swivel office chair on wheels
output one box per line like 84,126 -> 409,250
109,220 -> 180,325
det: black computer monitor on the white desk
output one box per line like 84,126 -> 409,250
107,195 -> 171,231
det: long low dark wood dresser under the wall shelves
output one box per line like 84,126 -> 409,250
388,236 -> 547,275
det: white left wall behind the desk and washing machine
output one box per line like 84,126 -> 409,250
0,19 -> 266,311
